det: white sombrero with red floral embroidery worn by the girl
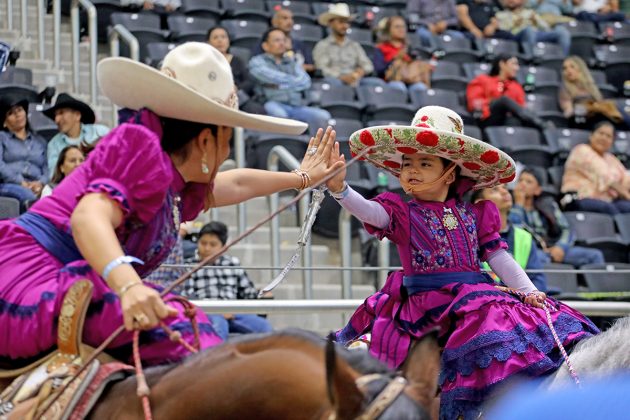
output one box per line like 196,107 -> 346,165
350,106 -> 516,189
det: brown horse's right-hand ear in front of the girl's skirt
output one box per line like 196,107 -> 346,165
402,330 -> 441,407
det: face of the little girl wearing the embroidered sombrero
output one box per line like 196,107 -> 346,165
400,153 -> 455,201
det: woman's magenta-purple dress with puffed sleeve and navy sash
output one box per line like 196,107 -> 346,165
0,111 -> 221,367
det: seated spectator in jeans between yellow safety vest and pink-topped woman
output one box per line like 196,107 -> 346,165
510,168 -> 604,267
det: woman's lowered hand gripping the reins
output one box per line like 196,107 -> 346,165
120,280 -> 177,331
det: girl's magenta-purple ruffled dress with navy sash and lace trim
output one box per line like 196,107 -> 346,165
337,193 -> 598,419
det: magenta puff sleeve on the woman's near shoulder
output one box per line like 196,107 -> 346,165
77,124 -> 173,223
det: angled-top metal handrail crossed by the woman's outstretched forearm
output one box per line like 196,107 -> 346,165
267,146 -> 313,299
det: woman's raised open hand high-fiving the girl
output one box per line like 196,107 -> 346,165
300,127 -> 345,186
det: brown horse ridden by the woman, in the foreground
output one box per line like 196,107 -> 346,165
82,330 -> 440,420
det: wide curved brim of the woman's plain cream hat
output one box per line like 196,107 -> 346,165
97,57 -> 308,134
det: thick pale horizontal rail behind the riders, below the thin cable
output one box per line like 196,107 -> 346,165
191,299 -> 630,316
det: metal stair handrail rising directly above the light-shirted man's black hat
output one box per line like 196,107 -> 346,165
70,0 -> 98,106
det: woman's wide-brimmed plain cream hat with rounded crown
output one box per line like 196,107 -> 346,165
97,42 -> 307,134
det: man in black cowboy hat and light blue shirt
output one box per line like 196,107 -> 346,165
44,93 -> 109,175
